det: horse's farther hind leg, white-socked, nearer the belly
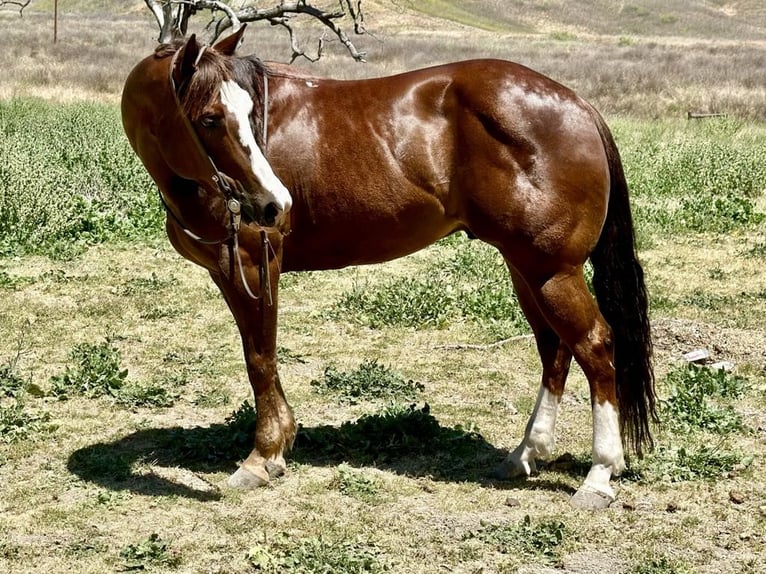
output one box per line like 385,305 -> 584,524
495,265 -> 572,478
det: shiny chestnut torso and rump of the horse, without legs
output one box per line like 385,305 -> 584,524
276,59 -> 608,274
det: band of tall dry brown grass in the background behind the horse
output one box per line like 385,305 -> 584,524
0,1 -> 766,121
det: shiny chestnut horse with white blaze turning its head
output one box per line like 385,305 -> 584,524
121,27 -> 657,508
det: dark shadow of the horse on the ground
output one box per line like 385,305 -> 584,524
68,404 -> 579,500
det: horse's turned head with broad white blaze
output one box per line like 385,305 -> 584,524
169,27 -> 292,226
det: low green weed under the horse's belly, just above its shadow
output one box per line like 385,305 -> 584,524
311,359 -> 425,404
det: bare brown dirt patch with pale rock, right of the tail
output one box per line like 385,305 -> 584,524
652,318 -> 766,370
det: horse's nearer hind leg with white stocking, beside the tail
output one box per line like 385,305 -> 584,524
510,265 -> 625,508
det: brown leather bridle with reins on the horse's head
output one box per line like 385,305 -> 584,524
165,46 -> 276,306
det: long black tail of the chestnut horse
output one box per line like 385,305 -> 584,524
591,110 -> 657,457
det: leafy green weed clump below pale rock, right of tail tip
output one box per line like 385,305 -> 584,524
660,365 -> 749,434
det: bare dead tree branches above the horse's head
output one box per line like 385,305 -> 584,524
148,0 -> 366,62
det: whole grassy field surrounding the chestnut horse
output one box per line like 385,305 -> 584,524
0,0 -> 766,574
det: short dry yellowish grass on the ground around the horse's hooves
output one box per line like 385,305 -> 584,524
0,235 -> 766,574
